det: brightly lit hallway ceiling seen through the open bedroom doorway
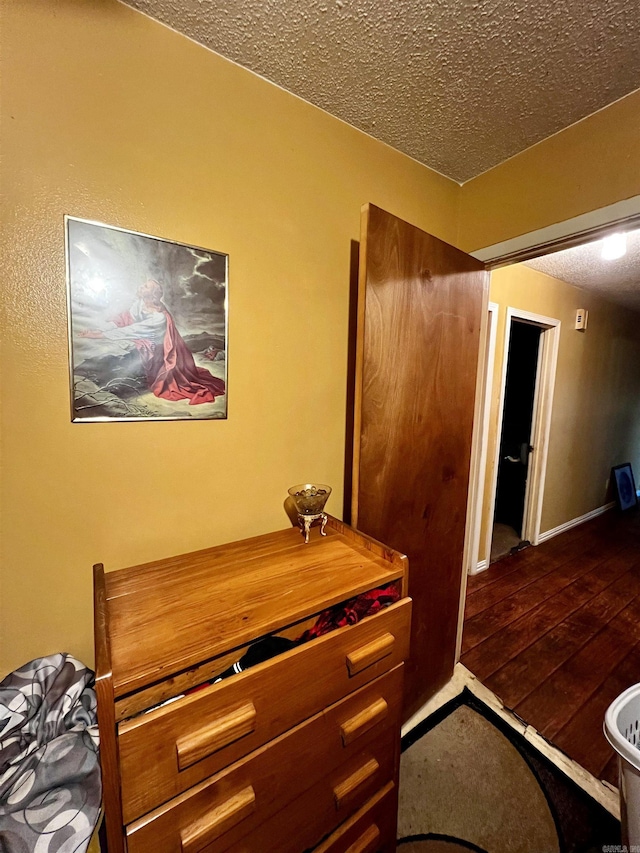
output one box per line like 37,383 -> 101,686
526,230 -> 640,311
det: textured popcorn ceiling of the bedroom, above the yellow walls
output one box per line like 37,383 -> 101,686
121,0 -> 640,182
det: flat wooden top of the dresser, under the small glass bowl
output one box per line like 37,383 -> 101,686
105,527 -> 404,696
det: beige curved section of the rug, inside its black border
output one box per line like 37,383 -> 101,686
398,705 -> 560,853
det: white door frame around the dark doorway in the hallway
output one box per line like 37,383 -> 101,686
485,306 -> 561,566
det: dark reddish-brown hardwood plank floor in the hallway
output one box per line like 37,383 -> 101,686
462,510 -> 640,785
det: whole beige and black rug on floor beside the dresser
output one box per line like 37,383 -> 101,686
397,688 -> 620,853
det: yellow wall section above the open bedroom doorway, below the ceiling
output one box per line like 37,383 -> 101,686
458,89 -> 640,252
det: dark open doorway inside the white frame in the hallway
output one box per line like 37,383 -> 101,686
491,319 -> 543,562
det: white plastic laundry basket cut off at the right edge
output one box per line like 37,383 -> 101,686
604,684 -> 640,850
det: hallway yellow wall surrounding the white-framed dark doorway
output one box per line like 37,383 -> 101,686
479,264 -> 640,560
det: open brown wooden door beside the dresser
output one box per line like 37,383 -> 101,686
351,205 -> 489,719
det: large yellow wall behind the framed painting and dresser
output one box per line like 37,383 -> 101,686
0,0 -> 459,672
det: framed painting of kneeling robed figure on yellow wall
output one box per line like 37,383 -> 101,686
65,216 -> 228,422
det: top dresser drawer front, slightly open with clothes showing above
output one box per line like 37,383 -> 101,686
118,599 -> 411,823
